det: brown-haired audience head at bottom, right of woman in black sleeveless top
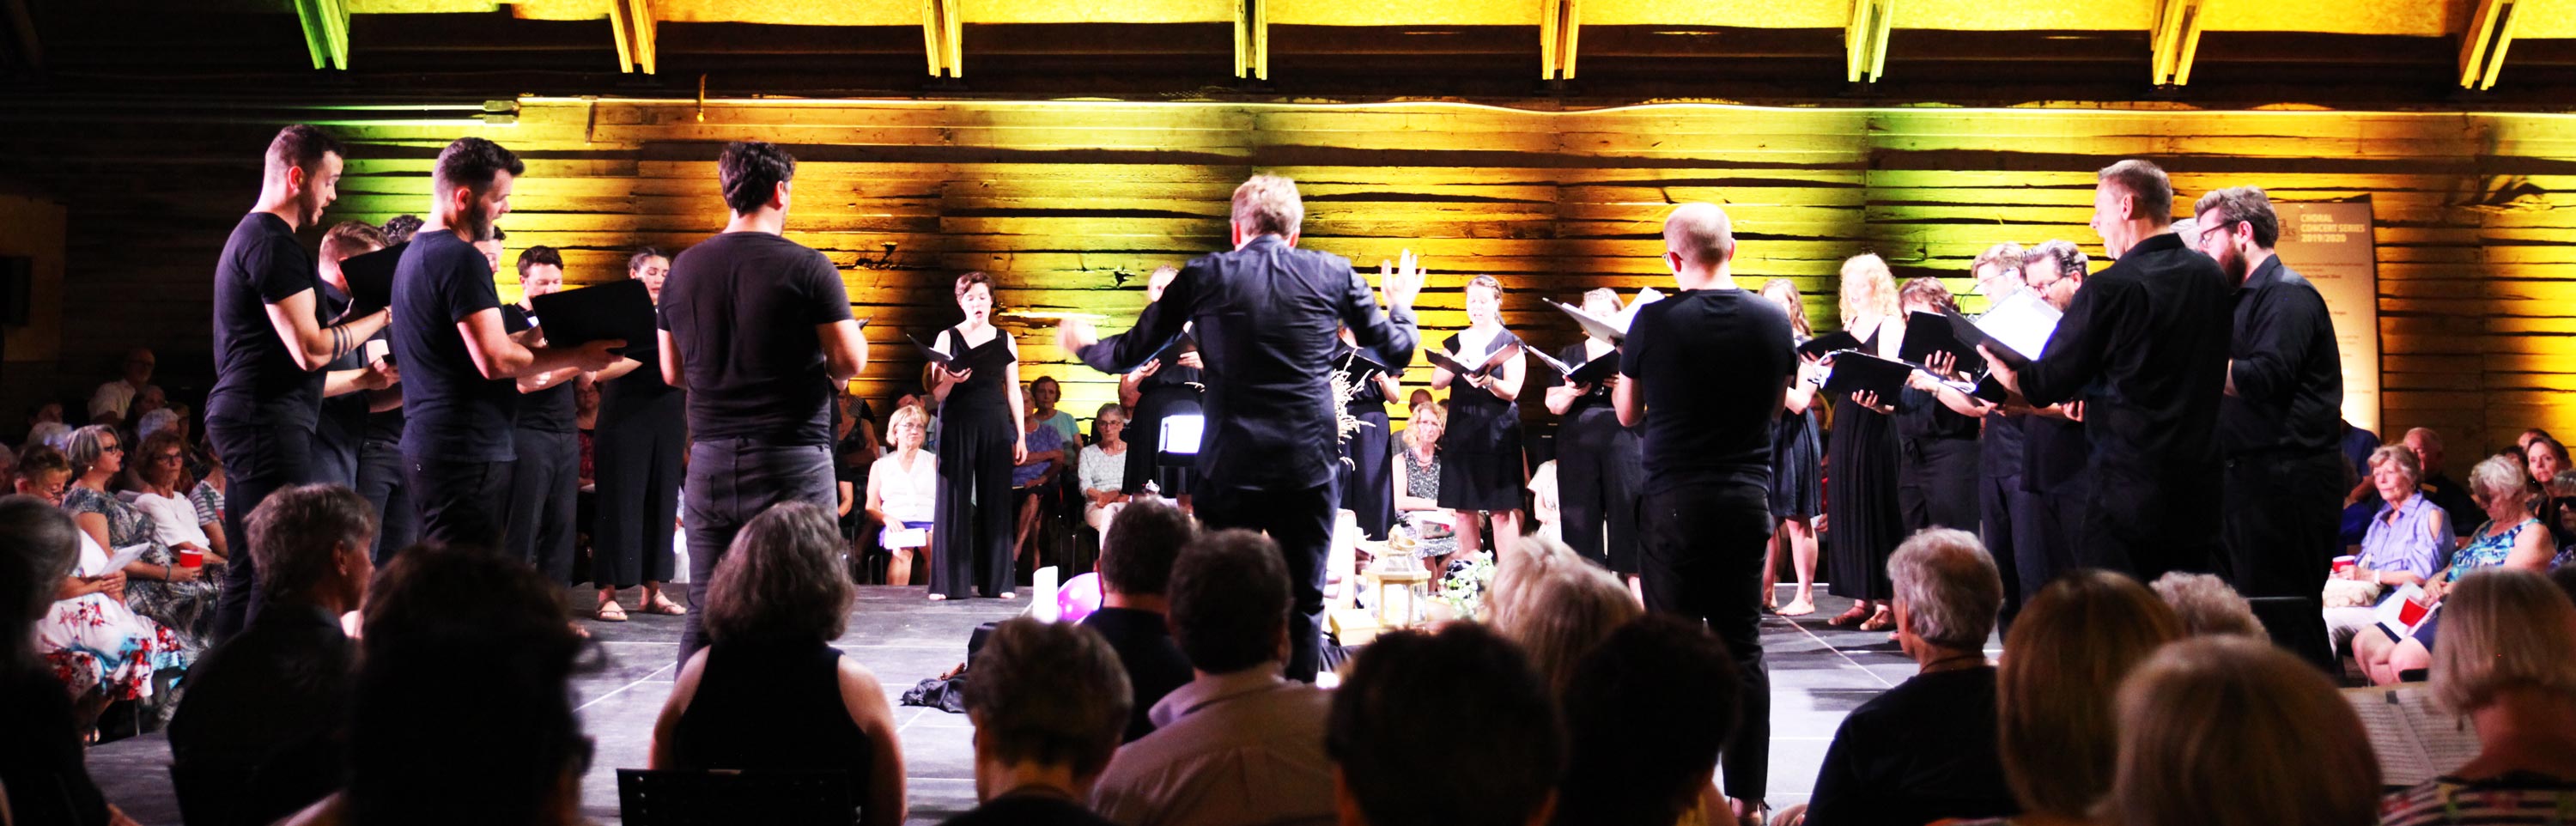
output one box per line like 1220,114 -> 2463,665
943,617 -> 1128,826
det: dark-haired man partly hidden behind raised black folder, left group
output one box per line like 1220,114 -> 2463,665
500,245 -> 582,581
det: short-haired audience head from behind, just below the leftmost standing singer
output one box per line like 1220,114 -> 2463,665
242,483 -> 376,615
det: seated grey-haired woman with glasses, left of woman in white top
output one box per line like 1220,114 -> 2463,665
62,424 -> 224,648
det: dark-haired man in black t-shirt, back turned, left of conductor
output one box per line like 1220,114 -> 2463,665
659,142 -> 868,664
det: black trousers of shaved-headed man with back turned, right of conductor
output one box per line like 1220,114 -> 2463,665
1638,483 -> 1772,800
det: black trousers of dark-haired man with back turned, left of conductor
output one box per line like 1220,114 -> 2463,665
680,440 -> 840,664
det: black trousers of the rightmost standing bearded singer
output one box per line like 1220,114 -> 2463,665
2218,450 -> 2344,669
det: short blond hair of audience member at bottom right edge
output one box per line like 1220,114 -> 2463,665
2432,568 -> 2576,715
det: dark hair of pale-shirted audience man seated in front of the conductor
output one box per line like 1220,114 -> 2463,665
1170,530 -> 1291,674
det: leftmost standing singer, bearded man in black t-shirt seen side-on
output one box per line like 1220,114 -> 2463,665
206,124 -> 386,643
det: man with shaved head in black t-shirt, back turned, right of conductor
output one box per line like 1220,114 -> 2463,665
1613,203 -> 1798,818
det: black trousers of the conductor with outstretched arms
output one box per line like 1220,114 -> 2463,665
1190,478 -> 1340,682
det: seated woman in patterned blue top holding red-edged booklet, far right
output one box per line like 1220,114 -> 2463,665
2352,455 -> 2555,684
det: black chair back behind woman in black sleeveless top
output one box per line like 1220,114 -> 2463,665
618,769 -> 858,826
